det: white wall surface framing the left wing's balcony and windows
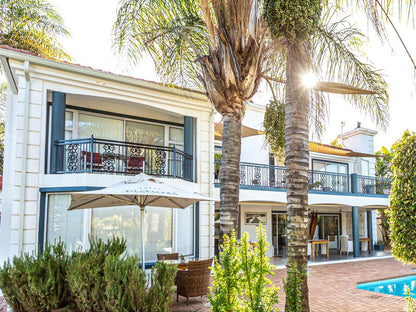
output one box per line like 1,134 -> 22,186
0,54 -> 214,260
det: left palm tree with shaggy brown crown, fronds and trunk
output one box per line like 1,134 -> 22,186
114,0 -> 385,246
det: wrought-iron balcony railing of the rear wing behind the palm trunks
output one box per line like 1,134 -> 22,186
215,160 -> 391,195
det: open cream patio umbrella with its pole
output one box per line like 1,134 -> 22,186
68,173 -> 215,270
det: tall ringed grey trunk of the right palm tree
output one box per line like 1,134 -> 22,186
285,42 -> 310,311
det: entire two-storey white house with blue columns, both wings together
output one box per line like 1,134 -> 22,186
0,46 -> 388,264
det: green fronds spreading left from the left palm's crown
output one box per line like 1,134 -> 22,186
114,0 -> 208,87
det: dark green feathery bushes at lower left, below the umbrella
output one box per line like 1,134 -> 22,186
0,238 -> 177,312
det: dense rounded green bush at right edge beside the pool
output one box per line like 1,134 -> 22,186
389,131 -> 416,263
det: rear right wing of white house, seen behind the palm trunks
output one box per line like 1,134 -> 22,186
215,104 -> 390,257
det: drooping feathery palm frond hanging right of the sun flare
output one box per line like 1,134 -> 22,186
313,13 -> 389,129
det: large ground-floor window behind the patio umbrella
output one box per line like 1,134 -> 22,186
47,194 -> 194,261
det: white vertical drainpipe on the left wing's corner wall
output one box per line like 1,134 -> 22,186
18,61 -> 30,255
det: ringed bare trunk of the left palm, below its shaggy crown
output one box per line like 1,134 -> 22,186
219,114 -> 241,243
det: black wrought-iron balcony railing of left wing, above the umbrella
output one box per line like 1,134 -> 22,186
52,136 -> 193,181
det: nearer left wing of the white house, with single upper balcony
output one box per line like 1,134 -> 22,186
0,47 -> 214,262
